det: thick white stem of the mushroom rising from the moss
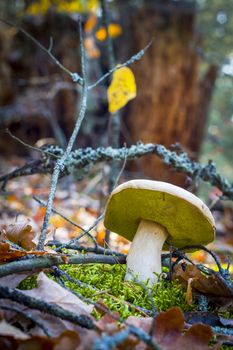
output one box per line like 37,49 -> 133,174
125,220 -> 168,285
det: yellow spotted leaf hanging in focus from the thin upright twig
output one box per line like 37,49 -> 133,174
107,67 -> 137,113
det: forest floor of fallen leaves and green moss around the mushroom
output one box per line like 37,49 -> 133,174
0,158 -> 233,350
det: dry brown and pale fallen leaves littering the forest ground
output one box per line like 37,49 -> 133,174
0,165 -> 233,350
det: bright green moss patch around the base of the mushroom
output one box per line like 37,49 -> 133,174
19,264 -> 194,319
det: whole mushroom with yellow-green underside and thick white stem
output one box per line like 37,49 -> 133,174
104,180 -> 215,285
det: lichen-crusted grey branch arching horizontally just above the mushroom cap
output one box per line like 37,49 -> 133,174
0,142 -> 233,200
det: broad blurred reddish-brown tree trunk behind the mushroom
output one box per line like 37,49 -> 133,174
119,1 -> 217,186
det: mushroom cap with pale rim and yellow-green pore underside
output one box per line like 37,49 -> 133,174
104,180 -> 215,249
